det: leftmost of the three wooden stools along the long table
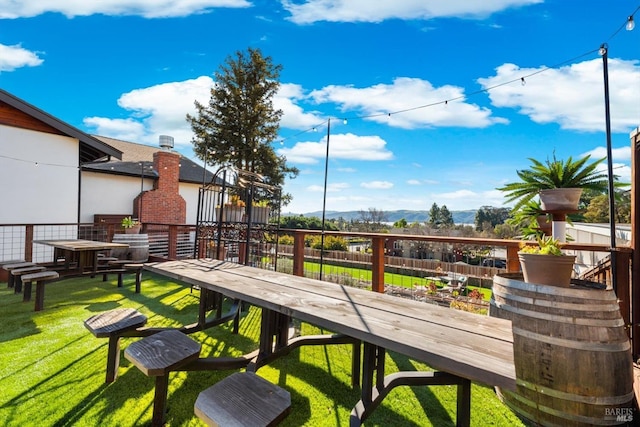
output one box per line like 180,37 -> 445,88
84,308 -> 147,383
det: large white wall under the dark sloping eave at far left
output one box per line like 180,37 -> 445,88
0,125 -> 80,224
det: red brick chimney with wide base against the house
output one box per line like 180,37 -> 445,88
133,150 -> 187,224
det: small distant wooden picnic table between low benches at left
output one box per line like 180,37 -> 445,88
33,239 -> 129,274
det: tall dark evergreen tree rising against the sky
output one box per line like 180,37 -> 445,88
187,48 -> 298,205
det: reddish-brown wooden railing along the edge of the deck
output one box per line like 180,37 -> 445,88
0,224 -> 640,359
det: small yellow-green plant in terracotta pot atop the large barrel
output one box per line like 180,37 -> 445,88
518,236 -> 576,287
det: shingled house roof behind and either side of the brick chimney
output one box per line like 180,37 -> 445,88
84,135 -> 221,184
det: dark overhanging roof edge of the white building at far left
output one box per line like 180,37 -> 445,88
0,89 -> 122,163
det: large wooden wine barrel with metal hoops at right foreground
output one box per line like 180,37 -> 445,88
489,274 -> 634,426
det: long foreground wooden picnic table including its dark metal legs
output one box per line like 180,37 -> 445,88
145,260 -> 516,426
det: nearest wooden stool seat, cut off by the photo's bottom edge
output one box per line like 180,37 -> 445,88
194,372 -> 291,427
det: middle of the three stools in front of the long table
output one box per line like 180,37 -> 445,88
124,329 -> 202,427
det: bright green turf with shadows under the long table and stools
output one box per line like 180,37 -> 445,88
0,273 -> 522,427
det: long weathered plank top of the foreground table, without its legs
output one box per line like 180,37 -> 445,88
145,260 -> 516,390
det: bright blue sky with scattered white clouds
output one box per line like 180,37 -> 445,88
0,0 -> 640,213
